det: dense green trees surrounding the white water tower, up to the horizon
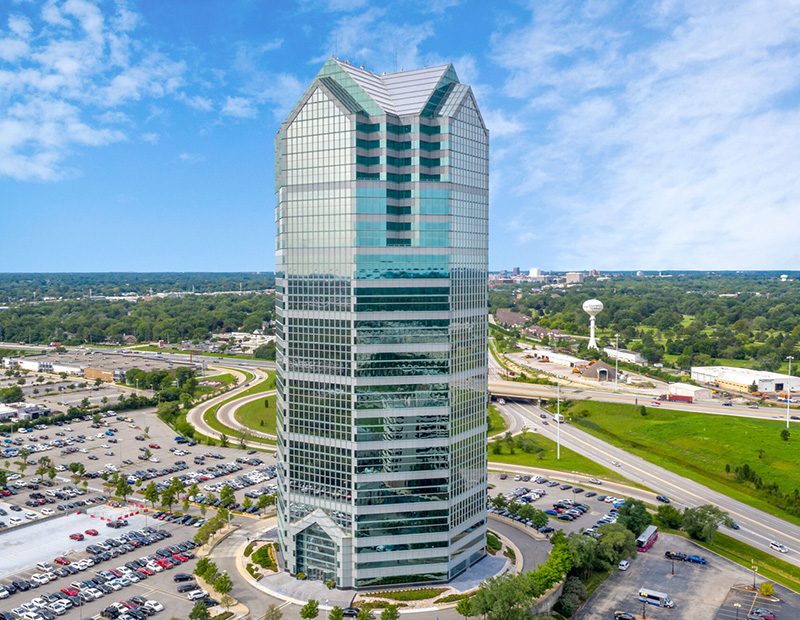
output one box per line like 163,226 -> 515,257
489,272 -> 800,370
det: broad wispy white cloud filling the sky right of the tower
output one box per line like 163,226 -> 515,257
487,0 -> 800,269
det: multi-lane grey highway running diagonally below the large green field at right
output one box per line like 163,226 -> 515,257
503,403 -> 800,566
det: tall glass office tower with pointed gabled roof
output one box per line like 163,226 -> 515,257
275,58 -> 489,588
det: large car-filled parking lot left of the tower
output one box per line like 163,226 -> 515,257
0,412 -> 275,620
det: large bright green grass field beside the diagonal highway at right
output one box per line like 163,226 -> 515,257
562,401 -> 800,525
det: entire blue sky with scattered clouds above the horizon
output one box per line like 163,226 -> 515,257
0,0 -> 800,271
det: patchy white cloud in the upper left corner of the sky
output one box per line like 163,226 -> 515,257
0,0 -> 203,181
